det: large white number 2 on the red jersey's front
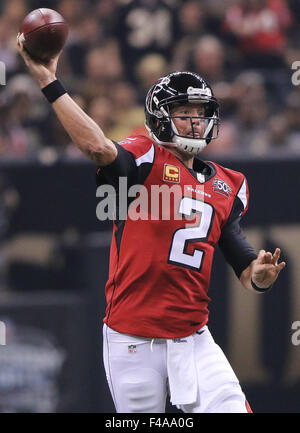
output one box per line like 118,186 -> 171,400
168,197 -> 214,272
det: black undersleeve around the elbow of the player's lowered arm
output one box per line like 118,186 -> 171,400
219,217 -> 257,278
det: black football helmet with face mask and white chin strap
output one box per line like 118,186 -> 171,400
145,72 -> 219,155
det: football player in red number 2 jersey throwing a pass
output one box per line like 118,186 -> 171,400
18,41 -> 285,413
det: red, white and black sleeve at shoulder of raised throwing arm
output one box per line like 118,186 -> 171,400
96,137 -> 155,189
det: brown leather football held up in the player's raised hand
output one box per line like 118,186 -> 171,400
19,8 -> 69,63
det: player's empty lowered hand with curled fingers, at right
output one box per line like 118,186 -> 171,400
251,248 -> 286,289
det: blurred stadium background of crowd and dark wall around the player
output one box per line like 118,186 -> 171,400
0,0 -> 300,413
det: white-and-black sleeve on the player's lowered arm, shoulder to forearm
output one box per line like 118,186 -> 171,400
219,176 -> 257,278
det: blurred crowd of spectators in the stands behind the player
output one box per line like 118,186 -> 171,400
0,0 -> 300,161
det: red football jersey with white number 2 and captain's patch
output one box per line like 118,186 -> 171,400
98,136 -> 248,338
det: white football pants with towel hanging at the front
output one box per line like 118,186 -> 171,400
103,325 -> 251,413
